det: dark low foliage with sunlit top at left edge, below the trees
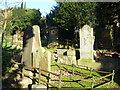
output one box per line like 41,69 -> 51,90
2,39 -> 22,75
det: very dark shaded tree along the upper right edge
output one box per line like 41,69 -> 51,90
96,2 -> 120,52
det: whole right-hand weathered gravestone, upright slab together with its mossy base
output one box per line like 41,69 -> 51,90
78,25 -> 101,68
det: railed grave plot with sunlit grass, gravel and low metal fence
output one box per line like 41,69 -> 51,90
50,64 -> 114,88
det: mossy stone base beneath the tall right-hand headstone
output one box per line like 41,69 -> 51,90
78,59 -> 101,70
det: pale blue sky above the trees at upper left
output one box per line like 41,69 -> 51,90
0,0 -> 56,16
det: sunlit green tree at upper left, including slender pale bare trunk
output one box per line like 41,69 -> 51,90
1,1 -> 41,42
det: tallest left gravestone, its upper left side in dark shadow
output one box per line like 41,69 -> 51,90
22,25 -> 41,66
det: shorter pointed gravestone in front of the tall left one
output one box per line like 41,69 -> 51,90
33,47 -> 51,82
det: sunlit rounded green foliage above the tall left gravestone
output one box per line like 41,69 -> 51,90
3,7 -> 41,34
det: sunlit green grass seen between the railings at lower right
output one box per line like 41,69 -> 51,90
51,60 -> 119,88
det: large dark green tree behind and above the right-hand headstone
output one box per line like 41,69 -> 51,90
47,2 -> 97,45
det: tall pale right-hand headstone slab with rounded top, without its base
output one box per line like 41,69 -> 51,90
80,25 -> 94,62
